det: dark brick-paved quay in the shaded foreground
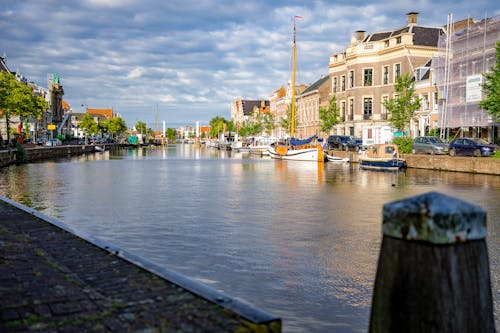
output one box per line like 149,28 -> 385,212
0,200 -> 281,333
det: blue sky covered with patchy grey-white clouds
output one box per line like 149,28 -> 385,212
0,0 -> 500,129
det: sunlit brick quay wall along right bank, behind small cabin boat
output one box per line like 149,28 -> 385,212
329,150 -> 500,175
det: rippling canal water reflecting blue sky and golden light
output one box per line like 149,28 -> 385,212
0,144 -> 500,332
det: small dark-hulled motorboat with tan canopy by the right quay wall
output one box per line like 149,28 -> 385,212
359,144 -> 406,171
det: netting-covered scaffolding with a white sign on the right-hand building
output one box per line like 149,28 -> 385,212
432,14 -> 500,136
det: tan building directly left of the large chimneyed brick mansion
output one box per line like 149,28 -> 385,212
296,75 -> 332,138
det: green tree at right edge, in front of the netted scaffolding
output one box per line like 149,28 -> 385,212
479,41 -> 500,121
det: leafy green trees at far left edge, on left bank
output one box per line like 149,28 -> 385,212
0,71 -> 48,142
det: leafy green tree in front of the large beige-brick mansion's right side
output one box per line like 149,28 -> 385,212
384,73 -> 420,136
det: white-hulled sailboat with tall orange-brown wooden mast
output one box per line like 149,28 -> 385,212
267,16 -> 325,162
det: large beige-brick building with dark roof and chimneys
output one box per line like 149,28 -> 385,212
328,12 -> 445,137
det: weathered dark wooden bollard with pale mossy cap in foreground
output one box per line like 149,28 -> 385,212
370,192 -> 495,333
